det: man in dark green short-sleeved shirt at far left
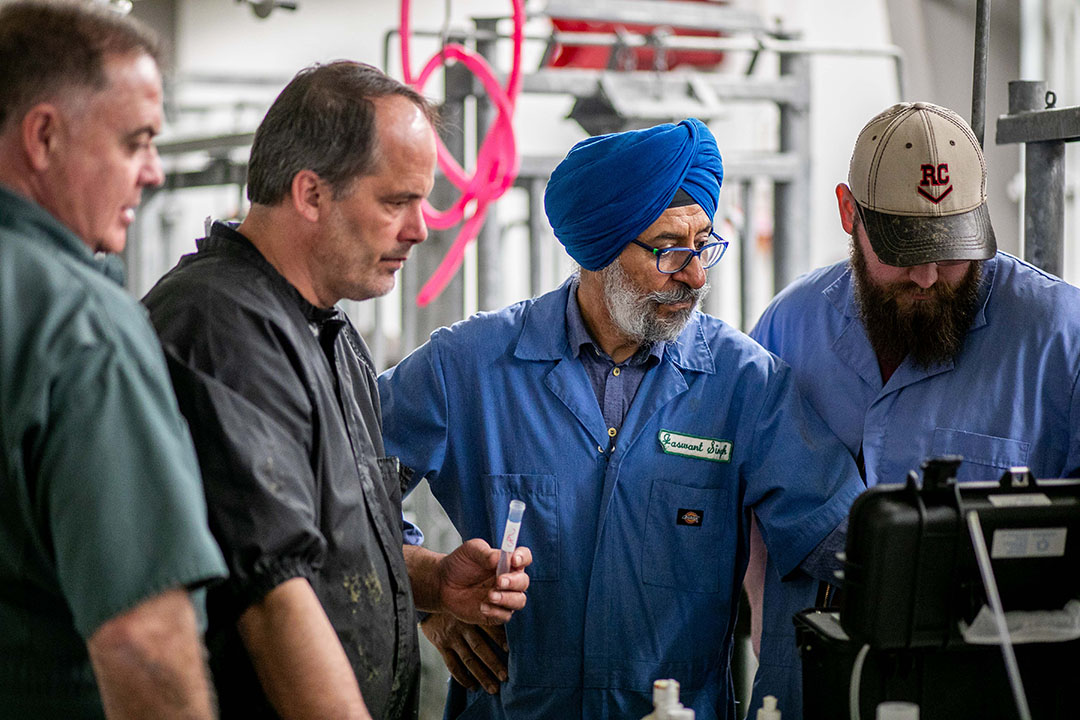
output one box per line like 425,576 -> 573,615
0,2 -> 225,719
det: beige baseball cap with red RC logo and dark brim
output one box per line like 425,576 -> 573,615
848,103 -> 997,268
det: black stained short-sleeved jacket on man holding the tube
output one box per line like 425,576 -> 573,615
144,223 -> 419,718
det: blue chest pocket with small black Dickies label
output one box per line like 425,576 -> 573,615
642,479 -> 733,593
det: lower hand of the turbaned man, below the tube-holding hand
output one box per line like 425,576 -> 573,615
420,613 -> 509,695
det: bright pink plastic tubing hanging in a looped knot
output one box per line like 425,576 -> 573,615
401,0 -> 525,308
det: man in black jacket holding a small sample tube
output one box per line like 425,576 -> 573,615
145,62 -> 529,719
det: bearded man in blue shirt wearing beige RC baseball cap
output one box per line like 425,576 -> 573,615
747,103 -> 1080,720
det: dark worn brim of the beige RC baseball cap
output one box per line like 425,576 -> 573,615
859,203 -> 998,268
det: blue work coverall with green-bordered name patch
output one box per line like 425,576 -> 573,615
379,282 -> 862,720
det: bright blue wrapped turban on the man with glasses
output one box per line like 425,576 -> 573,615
543,118 -> 724,270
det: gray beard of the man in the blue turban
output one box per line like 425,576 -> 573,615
599,260 -> 708,345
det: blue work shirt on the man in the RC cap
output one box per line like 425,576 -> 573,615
751,253 -> 1080,720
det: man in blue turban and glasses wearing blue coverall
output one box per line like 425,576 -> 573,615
379,119 -> 862,720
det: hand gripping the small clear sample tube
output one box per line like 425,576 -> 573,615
437,538 -> 532,625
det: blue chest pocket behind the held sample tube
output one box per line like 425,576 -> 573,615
482,473 -> 559,582
